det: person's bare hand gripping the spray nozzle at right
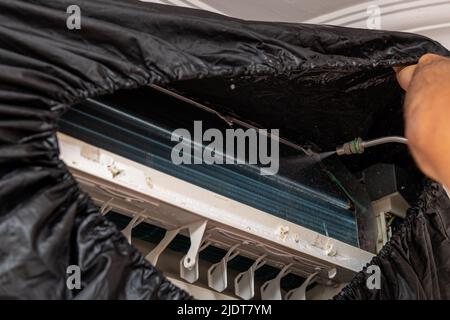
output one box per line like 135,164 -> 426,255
395,54 -> 450,187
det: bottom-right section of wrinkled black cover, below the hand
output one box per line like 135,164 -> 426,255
335,183 -> 450,300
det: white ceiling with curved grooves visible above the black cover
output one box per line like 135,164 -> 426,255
140,0 -> 450,48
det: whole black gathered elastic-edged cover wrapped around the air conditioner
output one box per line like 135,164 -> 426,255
0,0 -> 450,299
